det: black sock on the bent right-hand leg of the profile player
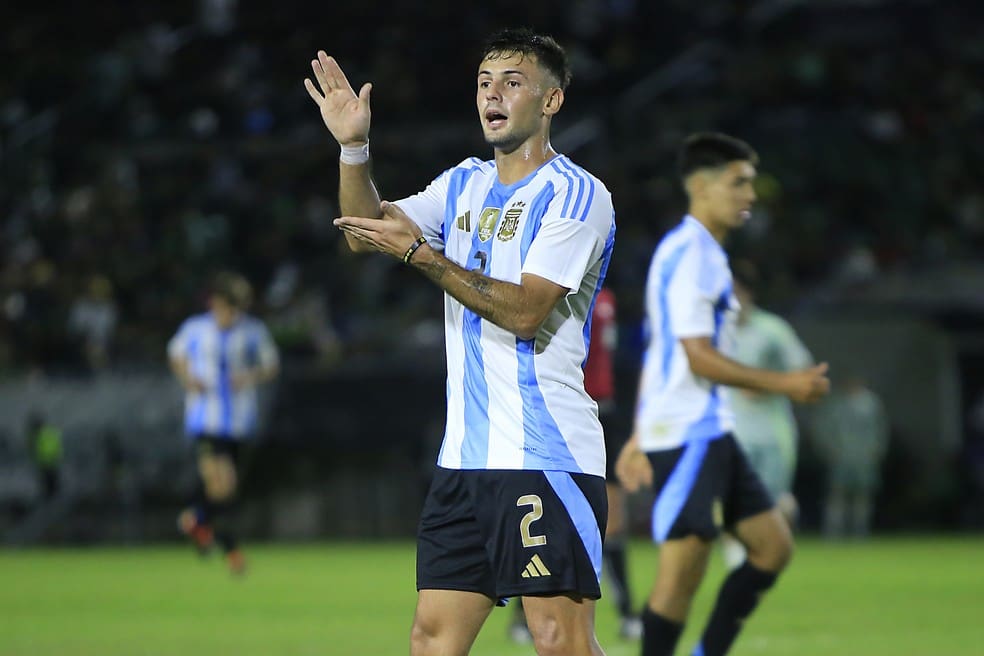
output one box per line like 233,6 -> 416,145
695,561 -> 779,656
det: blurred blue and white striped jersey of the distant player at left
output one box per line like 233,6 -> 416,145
167,312 -> 279,439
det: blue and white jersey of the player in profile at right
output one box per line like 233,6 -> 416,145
635,215 -> 739,451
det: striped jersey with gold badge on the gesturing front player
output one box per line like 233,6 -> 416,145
397,155 -> 615,476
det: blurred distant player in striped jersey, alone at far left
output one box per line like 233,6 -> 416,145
167,272 -> 280,574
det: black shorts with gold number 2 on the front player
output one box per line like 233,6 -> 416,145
417,467 -> 608,600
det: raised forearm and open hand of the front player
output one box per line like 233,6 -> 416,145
304,50 -> 383,252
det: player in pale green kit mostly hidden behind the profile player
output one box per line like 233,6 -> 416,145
722,260 -> 813,568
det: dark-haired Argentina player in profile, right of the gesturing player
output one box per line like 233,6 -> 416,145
616,133 -> 830,656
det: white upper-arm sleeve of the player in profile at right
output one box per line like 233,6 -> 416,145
665,243 -> 717,338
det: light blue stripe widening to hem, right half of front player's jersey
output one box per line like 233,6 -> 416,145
516,338 -> 581,472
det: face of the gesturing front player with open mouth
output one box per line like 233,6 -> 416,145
476,53 -> 563,153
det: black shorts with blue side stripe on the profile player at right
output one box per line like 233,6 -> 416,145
646,433 -> 775,542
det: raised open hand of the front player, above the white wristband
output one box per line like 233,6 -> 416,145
304,50 -> 372,146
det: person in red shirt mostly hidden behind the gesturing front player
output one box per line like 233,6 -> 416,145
509,287 -> 642,644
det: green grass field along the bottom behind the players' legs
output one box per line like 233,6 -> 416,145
0,538 -> 984,656
